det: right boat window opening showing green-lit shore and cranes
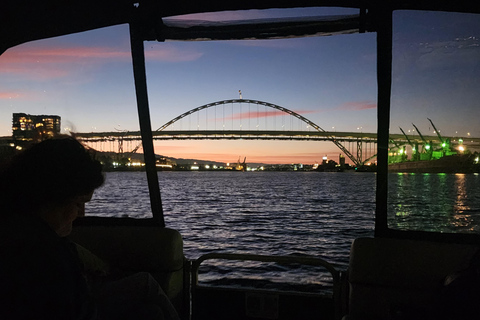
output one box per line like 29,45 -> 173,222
388,11 -> 480,234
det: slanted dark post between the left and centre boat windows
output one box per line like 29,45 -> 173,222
130,24 -> 165,227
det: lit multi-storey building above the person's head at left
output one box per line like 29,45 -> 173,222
12,113 -> 60,145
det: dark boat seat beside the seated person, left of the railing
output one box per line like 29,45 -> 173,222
69,225 -> 189,314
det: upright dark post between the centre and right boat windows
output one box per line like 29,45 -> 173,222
375,6 -> 392,236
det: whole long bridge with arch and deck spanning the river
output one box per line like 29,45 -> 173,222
76,99 -> 480,165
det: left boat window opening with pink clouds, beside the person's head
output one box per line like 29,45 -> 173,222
0,25 -> 157,219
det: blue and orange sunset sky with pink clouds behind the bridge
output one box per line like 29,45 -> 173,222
0,9 -> 480,164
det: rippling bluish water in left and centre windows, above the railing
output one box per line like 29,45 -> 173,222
87,172 -> 375,268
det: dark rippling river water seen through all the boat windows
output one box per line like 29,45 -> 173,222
87,171 -> 480,285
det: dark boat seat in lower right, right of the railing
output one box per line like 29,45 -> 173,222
345,238 -> 478,320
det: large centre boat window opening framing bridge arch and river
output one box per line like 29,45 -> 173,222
145,26 -> 377,282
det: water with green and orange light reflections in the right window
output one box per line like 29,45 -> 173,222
388,174 -> 480,233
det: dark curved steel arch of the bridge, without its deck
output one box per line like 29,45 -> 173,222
156,99 -> 360,165
